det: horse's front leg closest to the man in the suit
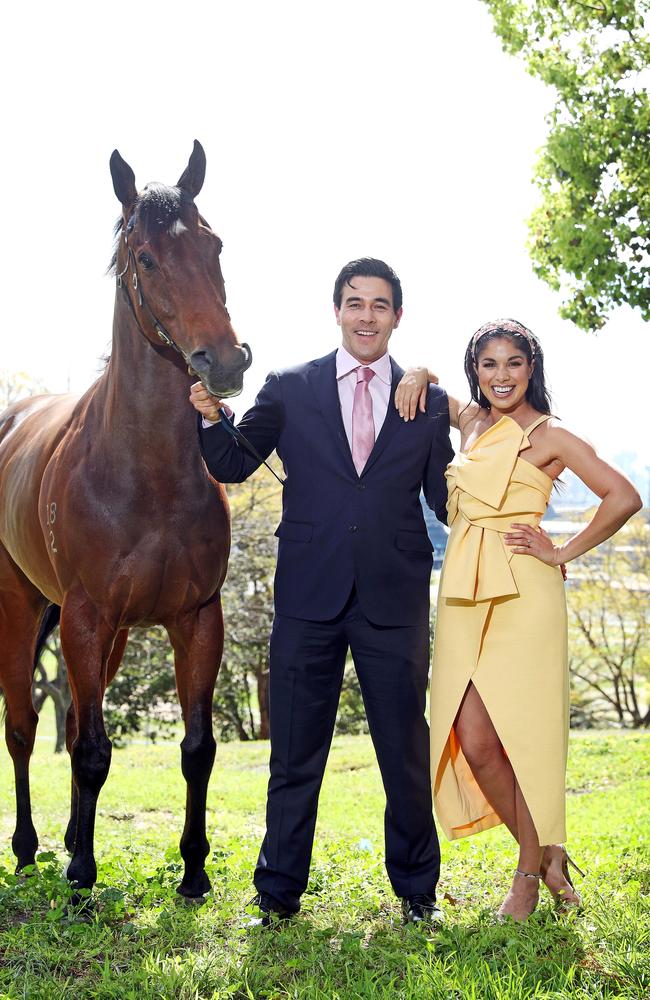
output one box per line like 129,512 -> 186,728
167,598 -> 223,899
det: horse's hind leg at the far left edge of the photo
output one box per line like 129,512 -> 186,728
0,552 -> 47,871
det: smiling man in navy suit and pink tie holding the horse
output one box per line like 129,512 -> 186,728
191,258 -> 453,924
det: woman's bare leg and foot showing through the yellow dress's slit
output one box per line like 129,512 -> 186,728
454,684 -> 542,920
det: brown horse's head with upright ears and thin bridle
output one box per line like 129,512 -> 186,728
111,141 -> 252,398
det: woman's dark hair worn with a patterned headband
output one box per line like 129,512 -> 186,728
465,319 -> 551,413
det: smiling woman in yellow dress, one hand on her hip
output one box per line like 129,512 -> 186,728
395,320 -> 641,920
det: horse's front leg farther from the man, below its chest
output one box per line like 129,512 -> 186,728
61,593 -> 117,889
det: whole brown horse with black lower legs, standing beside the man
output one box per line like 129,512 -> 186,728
0,142 -> 251,898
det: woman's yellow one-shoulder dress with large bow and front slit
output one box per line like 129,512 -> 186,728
431,416 -> 569,844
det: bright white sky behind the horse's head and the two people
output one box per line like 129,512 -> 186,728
0,0 -> 650,474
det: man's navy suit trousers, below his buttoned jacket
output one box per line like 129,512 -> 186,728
255,592 -> 440,911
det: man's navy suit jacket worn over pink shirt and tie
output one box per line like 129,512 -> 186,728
199,351 -> 453,626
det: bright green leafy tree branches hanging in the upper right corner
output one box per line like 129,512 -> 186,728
483,0 -> 650,330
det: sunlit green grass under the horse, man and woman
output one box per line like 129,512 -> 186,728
0,719 -> 650,1000
